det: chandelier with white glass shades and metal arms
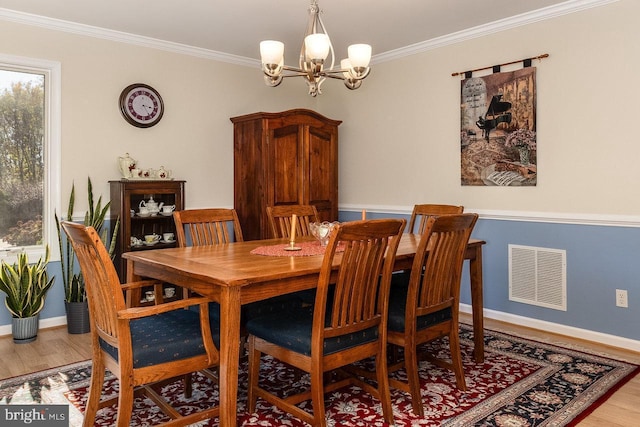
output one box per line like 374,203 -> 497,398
260,0 -> 371,96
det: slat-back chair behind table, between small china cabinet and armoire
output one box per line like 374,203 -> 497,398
173,208 -> 302,325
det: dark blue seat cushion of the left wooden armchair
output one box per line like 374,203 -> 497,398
100,310 -> 220,368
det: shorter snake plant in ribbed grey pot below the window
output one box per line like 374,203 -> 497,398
0,246 -> 55,344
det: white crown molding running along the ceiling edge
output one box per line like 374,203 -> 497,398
0,0 -> 619,68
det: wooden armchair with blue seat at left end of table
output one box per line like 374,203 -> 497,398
62,221 -> 220,427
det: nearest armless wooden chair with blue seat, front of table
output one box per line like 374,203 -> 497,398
246,219 -> 406,427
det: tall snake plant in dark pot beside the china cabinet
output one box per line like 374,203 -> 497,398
54,178 -> 120,334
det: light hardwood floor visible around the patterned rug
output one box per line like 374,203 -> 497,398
0,314 -> 640,427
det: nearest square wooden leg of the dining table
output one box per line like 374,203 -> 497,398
220,287 -> 240,427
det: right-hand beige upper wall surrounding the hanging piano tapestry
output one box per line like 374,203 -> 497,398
332,0 -> 640,215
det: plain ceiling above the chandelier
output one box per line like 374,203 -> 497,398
0,0 -> 568,64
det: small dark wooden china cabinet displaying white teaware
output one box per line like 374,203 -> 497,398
109,179 -> 185,282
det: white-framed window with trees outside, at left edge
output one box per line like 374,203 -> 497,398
0,55 -> 60,263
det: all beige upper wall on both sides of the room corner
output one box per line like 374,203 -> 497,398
0,0 -> 640,221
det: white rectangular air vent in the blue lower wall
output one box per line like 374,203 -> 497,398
509,245 -> 567,311
